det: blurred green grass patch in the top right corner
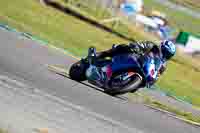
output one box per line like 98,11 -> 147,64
144,0 -> 200,34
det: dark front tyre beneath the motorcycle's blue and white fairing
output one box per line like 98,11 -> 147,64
105,75 -> 142,96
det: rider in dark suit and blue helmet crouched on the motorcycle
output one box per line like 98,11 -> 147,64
86,40 -> 176,86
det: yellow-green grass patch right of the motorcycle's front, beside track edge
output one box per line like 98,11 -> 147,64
158,59 -> 200,106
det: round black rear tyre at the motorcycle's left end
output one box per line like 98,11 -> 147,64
69,61 -> 86,82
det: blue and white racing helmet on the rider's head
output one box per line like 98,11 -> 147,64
160,40 -> 176,60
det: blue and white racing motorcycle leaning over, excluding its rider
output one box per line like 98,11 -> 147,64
69,49 -> 158,95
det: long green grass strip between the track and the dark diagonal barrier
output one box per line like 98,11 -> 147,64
0,0 -> 130,56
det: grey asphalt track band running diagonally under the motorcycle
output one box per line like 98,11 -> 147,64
0,30 -> 200,133
